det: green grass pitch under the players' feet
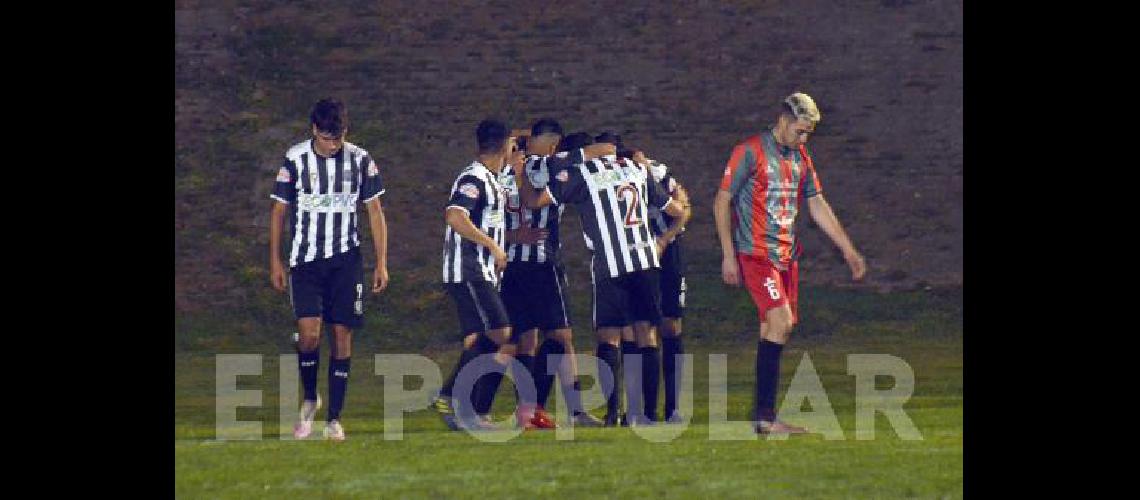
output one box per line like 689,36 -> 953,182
174,283 -> 963,498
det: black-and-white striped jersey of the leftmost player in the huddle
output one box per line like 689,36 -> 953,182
443,162 -> 506,284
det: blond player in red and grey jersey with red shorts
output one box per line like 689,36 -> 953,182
714,92 -> 866,434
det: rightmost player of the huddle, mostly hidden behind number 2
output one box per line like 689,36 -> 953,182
627,146 -> 689,424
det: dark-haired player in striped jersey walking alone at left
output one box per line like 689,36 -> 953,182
269,99 -> 388,441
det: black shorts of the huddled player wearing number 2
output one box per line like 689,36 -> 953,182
594,269 -> 661,328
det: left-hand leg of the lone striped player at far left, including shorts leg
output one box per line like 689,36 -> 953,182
290,261 -> 323,440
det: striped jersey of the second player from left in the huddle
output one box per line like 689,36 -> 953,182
503,155 -> 565,266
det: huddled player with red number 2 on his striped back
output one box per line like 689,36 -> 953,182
520,136 -> 689,426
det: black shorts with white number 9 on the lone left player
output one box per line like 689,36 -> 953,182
288,247 -> 364,328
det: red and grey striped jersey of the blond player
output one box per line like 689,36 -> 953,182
720,131 -> 823,269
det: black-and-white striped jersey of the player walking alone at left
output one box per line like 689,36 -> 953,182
269,139 -> 384,268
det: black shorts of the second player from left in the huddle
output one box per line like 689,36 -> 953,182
499,262 -> 570,334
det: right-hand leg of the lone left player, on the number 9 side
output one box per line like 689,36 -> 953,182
324,248 -> 364,441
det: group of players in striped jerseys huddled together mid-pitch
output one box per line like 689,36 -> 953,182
432,118 -> 690,429
